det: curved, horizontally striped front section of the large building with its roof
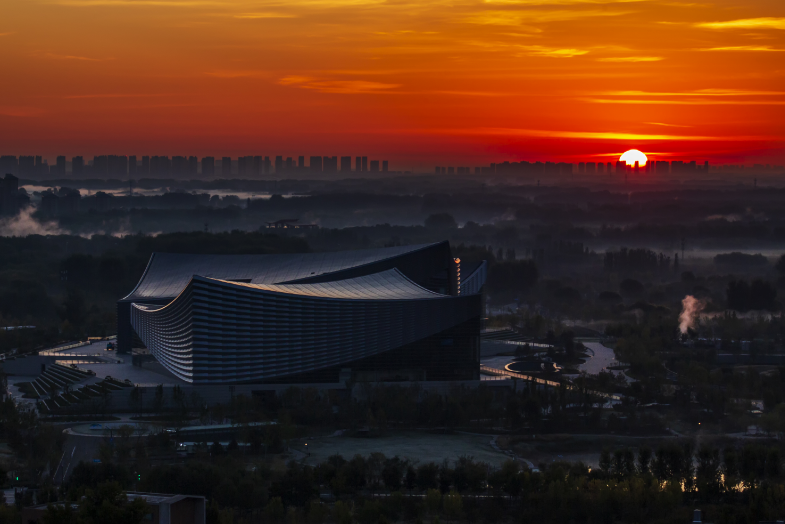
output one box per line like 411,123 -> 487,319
130,268 -> 484,384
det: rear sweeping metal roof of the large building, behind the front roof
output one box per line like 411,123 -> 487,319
123,243 -> 441,301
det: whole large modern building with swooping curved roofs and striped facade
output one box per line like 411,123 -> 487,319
117,242 -> 486,384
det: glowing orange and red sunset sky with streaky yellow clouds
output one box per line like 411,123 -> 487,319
0,0 -> 785,169
